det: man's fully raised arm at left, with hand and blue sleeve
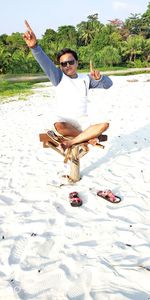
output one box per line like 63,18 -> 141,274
23,20 -> 63,86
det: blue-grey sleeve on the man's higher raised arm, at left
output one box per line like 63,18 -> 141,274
31,45 -> 63,86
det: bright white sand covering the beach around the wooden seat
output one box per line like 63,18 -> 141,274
0,74 -> 150,300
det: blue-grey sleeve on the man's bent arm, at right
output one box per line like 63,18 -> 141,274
89,75 -> 113,89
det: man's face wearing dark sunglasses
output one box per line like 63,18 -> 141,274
59,53 -> 78,77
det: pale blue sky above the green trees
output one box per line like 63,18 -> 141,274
0,0 -> 149,38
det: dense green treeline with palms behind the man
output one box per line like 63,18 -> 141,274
0,2 -> 150,74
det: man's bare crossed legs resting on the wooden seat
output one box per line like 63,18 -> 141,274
55,122 -> 109,148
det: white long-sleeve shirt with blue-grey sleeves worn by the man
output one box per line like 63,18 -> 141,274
32,45 -> 113,119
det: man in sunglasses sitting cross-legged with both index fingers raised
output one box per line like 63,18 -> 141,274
23,21 -> 112,150
